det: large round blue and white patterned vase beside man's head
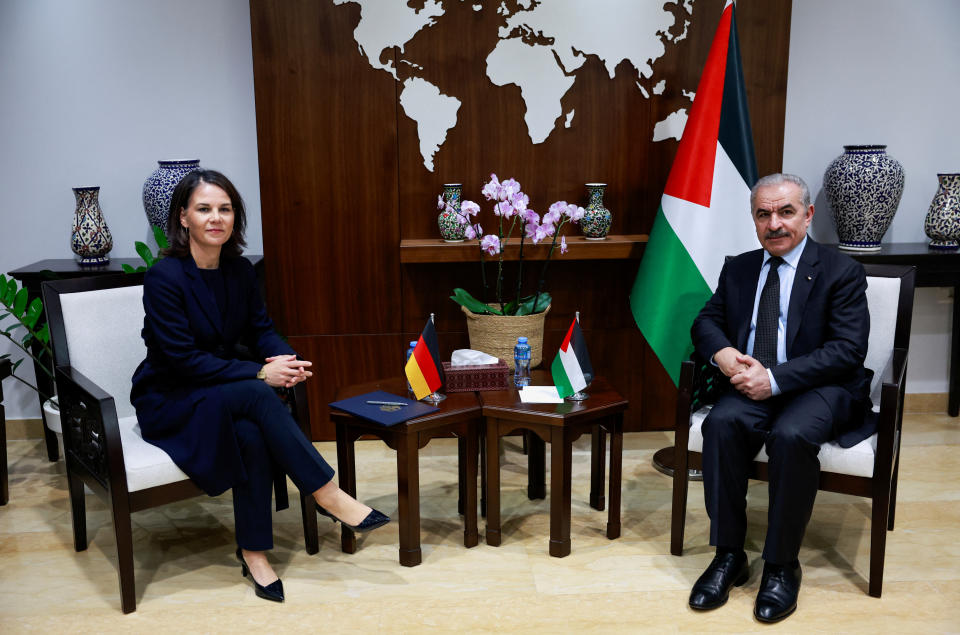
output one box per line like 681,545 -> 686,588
823,145 -> 903,251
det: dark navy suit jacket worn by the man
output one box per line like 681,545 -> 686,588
691,237 -> 876,447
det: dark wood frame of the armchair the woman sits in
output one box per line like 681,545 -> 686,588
43,274 -> 320,613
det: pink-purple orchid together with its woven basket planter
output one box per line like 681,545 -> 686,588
437,174 -> 584,368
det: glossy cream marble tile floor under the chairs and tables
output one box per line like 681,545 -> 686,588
0,415 -> 960,633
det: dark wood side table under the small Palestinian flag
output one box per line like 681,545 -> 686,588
478,371 -> 628,558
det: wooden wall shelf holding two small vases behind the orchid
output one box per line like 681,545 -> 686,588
400,234 -> 649,263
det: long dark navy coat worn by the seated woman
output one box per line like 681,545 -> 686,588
130,256 -> 294,495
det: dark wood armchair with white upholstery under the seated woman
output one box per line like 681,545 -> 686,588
43,274 -> 319,613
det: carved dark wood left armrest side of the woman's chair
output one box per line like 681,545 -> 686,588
56,366 -> 127,496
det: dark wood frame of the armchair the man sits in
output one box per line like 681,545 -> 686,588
670,264 -> 915,597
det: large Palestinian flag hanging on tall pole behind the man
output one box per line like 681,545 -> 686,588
630,0 -> 758,384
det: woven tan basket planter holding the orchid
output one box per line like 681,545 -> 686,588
460,305 -> 550,372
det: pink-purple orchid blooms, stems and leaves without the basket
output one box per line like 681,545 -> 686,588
437,174 -> 584,315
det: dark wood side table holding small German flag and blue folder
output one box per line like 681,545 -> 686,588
330,377 -> 482,567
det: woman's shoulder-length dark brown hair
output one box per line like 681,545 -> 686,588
160,168 -> 247,258
